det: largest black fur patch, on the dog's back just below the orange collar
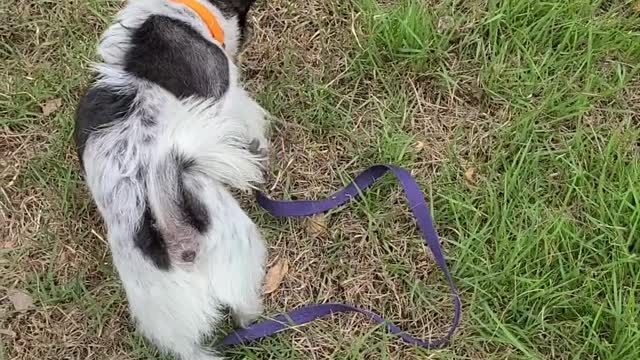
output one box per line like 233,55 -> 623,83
125,15 -> 229,100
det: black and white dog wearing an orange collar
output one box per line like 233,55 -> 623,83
75,0 -> 267,360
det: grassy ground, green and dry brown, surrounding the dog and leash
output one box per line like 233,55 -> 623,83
0,0 -> 640,360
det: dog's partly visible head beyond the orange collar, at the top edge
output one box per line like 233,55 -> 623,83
207,0 -> 255,54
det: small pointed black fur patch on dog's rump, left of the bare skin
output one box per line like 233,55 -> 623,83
133,207 -> 171,270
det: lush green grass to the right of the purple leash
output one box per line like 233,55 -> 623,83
350,1 -> 640,359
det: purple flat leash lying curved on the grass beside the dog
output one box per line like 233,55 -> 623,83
222,165 -> 462,348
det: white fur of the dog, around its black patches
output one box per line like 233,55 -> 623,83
83,0 -> 267,360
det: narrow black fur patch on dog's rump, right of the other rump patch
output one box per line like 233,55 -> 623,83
174,154 -> 210,234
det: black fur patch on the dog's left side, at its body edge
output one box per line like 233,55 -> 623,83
74,87 -> 136,164
